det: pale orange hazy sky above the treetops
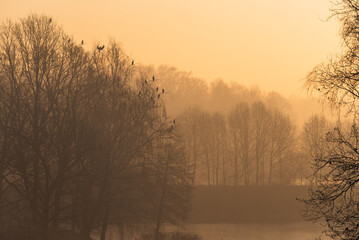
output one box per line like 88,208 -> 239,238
0,0 -> 340,96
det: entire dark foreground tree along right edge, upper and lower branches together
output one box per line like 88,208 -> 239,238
305,0 -> 359,239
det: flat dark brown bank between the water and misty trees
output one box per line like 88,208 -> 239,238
187,186 -> 308,223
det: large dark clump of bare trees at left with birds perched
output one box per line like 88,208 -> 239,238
0,15 -> 192,240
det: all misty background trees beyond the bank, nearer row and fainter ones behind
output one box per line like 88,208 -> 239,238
141,66 -> 332,186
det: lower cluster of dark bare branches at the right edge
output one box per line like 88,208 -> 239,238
304,125 -> 359,239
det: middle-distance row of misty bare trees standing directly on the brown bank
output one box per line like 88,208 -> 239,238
179,101 -> 329,186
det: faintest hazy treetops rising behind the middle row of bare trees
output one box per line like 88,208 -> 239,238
140,65 -> 296,117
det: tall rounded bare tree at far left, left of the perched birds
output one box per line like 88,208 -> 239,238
0,15 -> 91,239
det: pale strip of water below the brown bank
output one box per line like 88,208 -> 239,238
181,222 -> 329,240
